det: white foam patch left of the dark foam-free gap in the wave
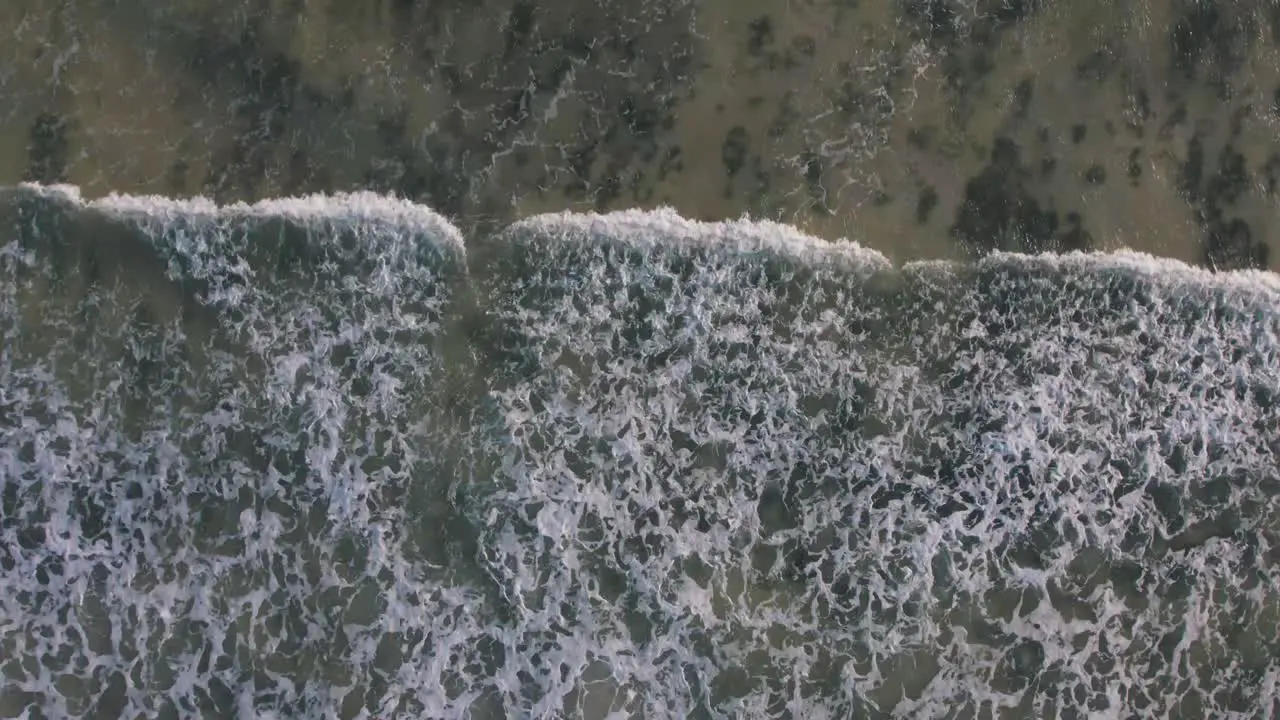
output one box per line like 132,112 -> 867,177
0,187 -> 484,716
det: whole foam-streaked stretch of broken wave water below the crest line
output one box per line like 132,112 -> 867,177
0,186 -> 1280,719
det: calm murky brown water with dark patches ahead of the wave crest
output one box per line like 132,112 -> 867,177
0,0 -> 1280,268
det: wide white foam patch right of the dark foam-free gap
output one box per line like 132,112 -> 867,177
477,206 -> 1280,717
